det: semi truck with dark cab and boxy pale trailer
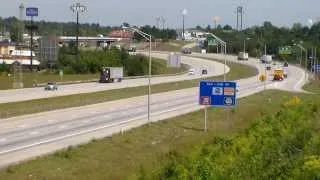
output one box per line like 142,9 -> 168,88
99,67 -> 123,83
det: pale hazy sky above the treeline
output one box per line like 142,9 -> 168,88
0,0 -> 320,28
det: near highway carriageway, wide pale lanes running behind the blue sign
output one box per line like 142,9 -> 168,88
0,53 -> 306,166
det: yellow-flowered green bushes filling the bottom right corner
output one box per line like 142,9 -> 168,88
153,97 -> 320,179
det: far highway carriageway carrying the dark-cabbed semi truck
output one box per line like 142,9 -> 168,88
0,53 -> 230,103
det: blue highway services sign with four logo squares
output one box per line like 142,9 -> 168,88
199,81 -> 237,107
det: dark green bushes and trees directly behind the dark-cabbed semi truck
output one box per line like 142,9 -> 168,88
53,46 -> 169,76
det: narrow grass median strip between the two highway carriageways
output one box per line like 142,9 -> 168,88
0,58 -> 257,118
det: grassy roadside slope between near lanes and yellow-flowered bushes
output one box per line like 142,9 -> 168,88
0,91 -> 314,180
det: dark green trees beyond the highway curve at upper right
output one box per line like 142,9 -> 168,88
197,22 -> 320,60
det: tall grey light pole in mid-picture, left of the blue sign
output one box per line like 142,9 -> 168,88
122,26 -> 152,123
